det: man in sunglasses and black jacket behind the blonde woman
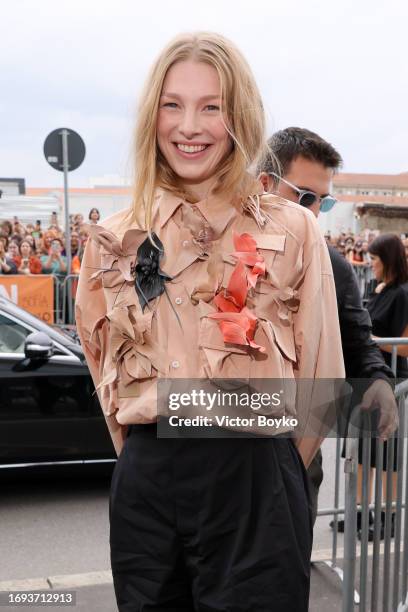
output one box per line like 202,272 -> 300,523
259,127 -> 398,531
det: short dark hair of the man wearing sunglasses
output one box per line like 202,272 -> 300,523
258,127 -> 343,176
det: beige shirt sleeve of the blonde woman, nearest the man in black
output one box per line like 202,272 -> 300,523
293,225 -> 345,467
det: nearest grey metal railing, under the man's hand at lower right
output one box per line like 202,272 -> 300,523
343,380 -> 408,612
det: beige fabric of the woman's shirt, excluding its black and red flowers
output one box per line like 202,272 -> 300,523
76,186 -> 344,462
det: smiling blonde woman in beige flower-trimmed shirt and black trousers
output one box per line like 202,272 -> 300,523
76,33 -> 343,612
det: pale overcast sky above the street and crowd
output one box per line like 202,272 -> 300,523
0,0 -> 408,186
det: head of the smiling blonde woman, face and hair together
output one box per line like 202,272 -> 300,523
133,34 -> 266,228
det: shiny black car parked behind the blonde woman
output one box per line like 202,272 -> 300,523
0,295 -> 116,473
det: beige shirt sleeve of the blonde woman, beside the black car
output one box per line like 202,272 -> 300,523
75,233 -> 127,455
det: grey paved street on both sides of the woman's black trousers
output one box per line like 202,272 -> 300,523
0,440 -> 350,612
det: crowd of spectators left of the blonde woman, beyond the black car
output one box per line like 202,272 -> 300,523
0,208 -> 100,277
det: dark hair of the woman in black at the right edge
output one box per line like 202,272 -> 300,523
368,234 -> 408,285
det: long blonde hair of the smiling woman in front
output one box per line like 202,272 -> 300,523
132,32 -> 266,232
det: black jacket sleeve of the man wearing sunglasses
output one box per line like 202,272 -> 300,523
328,246 -> 394,385
